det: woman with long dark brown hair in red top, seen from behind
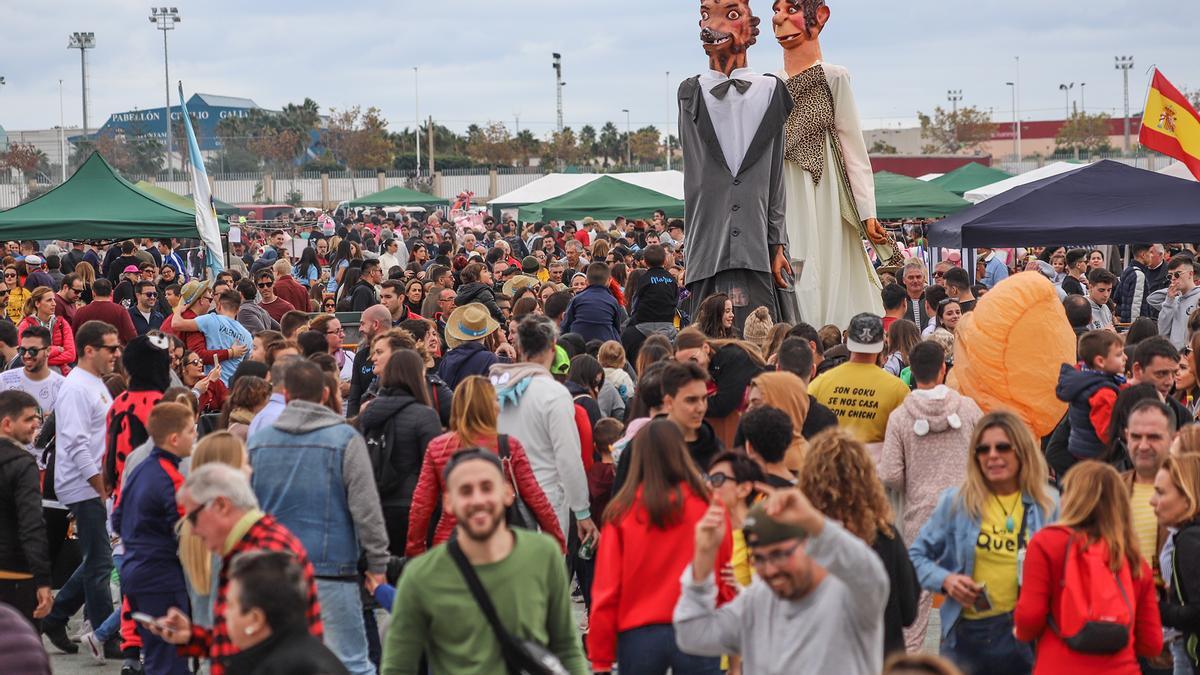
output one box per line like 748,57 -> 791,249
588,419 -> 734,675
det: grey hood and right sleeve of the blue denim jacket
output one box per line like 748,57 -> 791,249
272,401 -> 391,574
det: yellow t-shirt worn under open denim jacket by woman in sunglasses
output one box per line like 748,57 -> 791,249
962,492 -> 1025,619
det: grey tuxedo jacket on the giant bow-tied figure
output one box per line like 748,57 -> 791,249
679,76 -> 792,285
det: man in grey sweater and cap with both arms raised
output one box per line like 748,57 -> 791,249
674,480 -> 888,675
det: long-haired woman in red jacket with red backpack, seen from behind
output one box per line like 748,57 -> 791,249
1015,461 -> 1163,675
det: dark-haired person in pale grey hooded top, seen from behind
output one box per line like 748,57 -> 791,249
490,314 -> 599,543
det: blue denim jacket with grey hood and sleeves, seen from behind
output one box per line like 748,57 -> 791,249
250,401 -> 388,577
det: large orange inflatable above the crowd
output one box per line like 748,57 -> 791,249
947,271 -> 1075,437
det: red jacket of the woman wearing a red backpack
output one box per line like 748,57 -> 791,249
1013,527 -> 1163,675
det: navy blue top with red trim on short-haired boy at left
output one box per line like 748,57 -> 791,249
113,447 -> 187,593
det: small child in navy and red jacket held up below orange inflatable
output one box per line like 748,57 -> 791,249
1055,326 -> 1126,460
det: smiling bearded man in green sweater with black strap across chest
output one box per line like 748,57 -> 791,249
382,448 -> 585,675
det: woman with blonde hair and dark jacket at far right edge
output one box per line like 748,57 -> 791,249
1150,451 -> 1200,673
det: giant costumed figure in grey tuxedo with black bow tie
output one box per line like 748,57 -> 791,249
679,0 -> 797,325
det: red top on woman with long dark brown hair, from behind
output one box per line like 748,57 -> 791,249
588,484 -> 736,671
